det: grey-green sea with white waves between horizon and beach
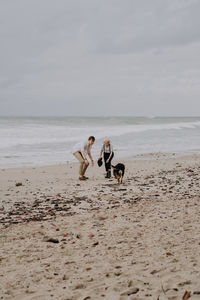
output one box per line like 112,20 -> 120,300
0,117 -> 200,168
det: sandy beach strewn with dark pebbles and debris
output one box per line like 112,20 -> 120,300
0,153 -> 200,300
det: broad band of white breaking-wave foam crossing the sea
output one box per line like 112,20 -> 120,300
0,121 -> 200,149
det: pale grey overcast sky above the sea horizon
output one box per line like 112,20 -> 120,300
0,0 -> 200,116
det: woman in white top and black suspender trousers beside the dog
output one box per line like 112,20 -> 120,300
99,140 -> 114,178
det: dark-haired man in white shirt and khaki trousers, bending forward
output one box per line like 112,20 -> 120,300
73,136 -> 95,180
